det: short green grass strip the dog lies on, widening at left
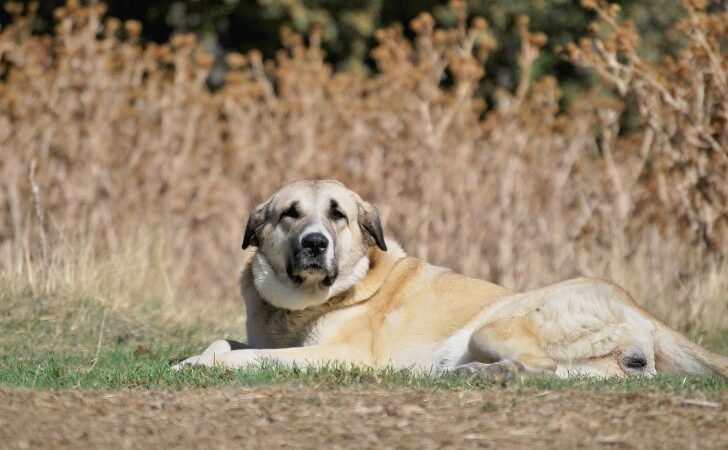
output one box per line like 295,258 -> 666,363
0,296 -> 728,392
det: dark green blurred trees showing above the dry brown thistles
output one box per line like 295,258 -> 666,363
0,0 -> 688,103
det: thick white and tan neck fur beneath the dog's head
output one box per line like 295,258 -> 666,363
245,241 -> 406,311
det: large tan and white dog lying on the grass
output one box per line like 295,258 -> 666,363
178,180 -> 728,377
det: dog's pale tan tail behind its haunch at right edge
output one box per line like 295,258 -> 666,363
655,323 -> 728,379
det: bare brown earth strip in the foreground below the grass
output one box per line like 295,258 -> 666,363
0,386 -> 728,449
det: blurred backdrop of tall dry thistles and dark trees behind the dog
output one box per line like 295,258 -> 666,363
0,0 -> 728,330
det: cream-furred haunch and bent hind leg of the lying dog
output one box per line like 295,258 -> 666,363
452,279 -> 655,378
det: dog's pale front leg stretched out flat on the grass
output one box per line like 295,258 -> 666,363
173,341 -> 368,369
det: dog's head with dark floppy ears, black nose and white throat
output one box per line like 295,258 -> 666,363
243,180 -> 387,309
